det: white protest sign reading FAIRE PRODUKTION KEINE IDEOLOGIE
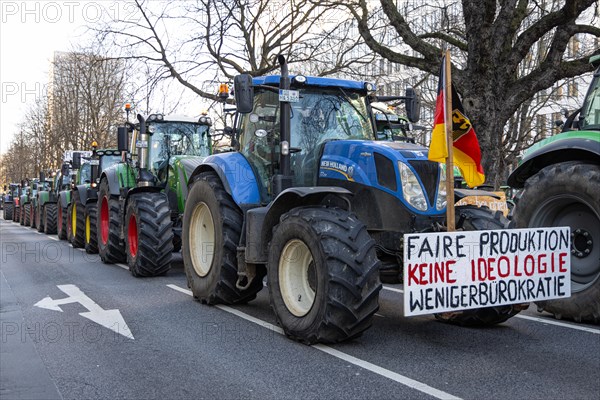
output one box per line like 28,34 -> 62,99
404,227 -> 571,316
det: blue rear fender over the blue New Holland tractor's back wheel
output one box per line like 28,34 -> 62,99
188,153 -> 260,206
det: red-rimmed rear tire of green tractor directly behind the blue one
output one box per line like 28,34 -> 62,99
96,179 -> 127,263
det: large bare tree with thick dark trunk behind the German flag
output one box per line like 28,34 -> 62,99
338,0 -> 600,186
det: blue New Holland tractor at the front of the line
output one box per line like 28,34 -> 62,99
182,57 -> 522,343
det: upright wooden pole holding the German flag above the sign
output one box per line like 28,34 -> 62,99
444,50 -> 456,232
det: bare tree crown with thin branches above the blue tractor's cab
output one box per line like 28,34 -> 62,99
91,0 -> 373,100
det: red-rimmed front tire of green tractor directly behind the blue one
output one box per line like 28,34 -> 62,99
125,193 -> 173,277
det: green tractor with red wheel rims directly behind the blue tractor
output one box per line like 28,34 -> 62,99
97,109 -> 212,277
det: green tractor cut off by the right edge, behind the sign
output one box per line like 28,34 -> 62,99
508,56 -> 600,322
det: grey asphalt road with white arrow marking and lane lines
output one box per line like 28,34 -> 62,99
0,216 -> 600,400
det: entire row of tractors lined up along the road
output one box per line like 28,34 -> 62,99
5,57 -> 600,343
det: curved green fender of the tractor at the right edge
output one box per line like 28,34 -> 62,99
507,134 -> 600,188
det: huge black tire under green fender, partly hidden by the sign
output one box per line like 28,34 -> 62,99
513,161 -> 600,322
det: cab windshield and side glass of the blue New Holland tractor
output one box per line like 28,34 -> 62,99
240,87 -> 375,193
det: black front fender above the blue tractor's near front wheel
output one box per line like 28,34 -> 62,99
246,186 -> 352,263
